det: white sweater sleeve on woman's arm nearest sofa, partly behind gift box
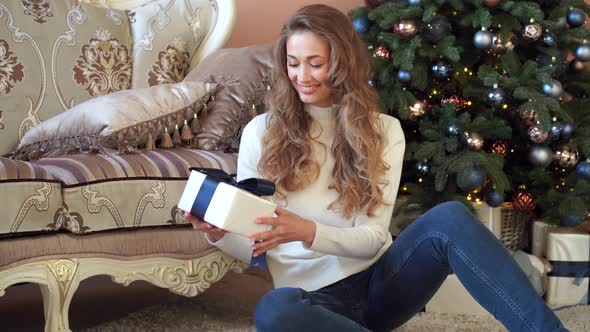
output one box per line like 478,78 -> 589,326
205,116 -> 264,263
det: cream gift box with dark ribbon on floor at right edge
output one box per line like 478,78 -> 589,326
545,227 -> 590,308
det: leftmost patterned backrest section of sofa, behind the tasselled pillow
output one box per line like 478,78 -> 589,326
0,0 -> 132,155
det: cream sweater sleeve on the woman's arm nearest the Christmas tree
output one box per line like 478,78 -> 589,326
305,115 -> 405,258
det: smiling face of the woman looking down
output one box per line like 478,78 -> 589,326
287,31 -> 332,107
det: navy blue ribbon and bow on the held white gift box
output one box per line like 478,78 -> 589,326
189,167 -> 276,271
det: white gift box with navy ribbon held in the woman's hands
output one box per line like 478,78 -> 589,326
178,168 -> 276,237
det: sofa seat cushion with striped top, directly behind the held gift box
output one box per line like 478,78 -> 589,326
32,148 -> 237,233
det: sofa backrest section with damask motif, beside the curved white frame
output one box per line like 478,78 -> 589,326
129,0 -> 217,88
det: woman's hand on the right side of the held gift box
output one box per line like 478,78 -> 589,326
250,207 -> 315,256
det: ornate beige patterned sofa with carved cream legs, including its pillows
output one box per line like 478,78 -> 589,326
0,0 -> 270,331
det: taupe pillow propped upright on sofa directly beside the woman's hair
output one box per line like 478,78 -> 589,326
185,45 -> 272,151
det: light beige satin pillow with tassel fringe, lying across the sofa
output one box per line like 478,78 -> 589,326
14,82 -> 216,160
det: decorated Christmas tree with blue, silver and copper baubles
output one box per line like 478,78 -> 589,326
350,0 -> 590,225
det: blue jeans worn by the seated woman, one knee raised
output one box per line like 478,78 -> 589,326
254,202 -> 567,332
